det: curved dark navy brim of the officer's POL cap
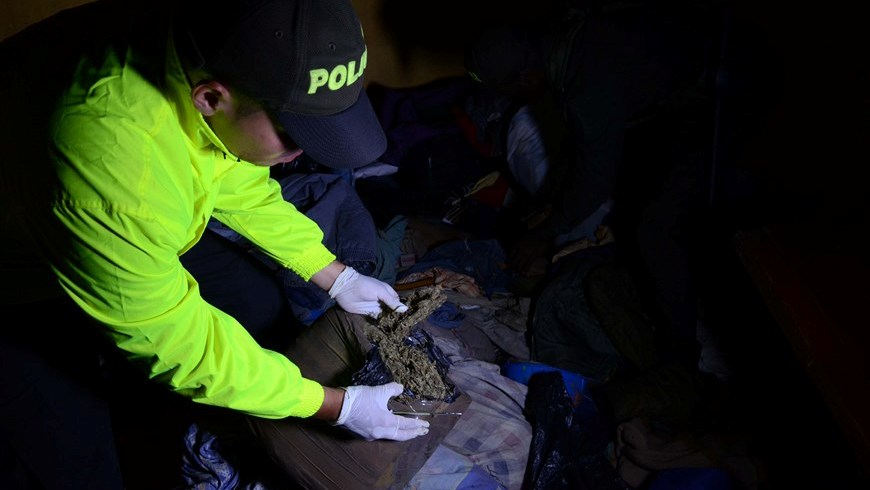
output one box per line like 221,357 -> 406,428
277,90 -> 387,168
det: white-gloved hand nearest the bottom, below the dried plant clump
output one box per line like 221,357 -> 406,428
335,382 -> 429,441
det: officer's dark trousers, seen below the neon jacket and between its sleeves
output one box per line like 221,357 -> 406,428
0,232 -> 296,490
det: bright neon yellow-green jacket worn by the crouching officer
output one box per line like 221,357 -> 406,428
3,27 -> 335,418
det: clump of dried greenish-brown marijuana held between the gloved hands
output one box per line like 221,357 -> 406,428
365,286 -> 451,400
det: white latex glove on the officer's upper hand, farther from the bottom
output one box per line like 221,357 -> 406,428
329,266 -> 408,318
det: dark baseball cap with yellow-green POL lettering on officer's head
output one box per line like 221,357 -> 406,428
176,0 -> 387,168
